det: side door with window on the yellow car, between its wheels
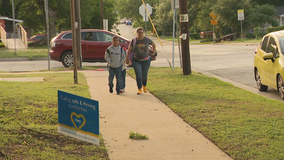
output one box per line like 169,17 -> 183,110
265,37 -> 279,88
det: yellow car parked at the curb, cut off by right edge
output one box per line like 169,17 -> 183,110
254,30 -> 284,100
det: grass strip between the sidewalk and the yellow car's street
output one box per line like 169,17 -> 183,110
128,67 -> 284,160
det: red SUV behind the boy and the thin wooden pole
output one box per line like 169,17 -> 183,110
49,29 -> 130,67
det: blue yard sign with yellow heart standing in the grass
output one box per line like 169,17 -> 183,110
58,90 -> 100,145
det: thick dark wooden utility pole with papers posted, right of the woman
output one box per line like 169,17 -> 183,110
179,0 -> 191,75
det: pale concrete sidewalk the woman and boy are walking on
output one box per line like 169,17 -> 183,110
83,71 -> 231,160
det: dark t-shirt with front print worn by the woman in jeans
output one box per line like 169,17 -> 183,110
130,37 -> 153,61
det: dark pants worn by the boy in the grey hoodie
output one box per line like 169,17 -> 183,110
108,66 -> 122,92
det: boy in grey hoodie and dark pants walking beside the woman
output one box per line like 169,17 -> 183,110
105,36 -> 125,94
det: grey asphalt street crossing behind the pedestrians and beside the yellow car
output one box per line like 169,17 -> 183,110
0,25 -> 280,100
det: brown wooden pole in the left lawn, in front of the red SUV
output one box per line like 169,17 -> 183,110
70,0 -> 82,84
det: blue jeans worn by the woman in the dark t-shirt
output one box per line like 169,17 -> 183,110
132,58 -> 151,89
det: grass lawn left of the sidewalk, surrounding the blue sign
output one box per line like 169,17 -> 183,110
0,72 -> 109,160
